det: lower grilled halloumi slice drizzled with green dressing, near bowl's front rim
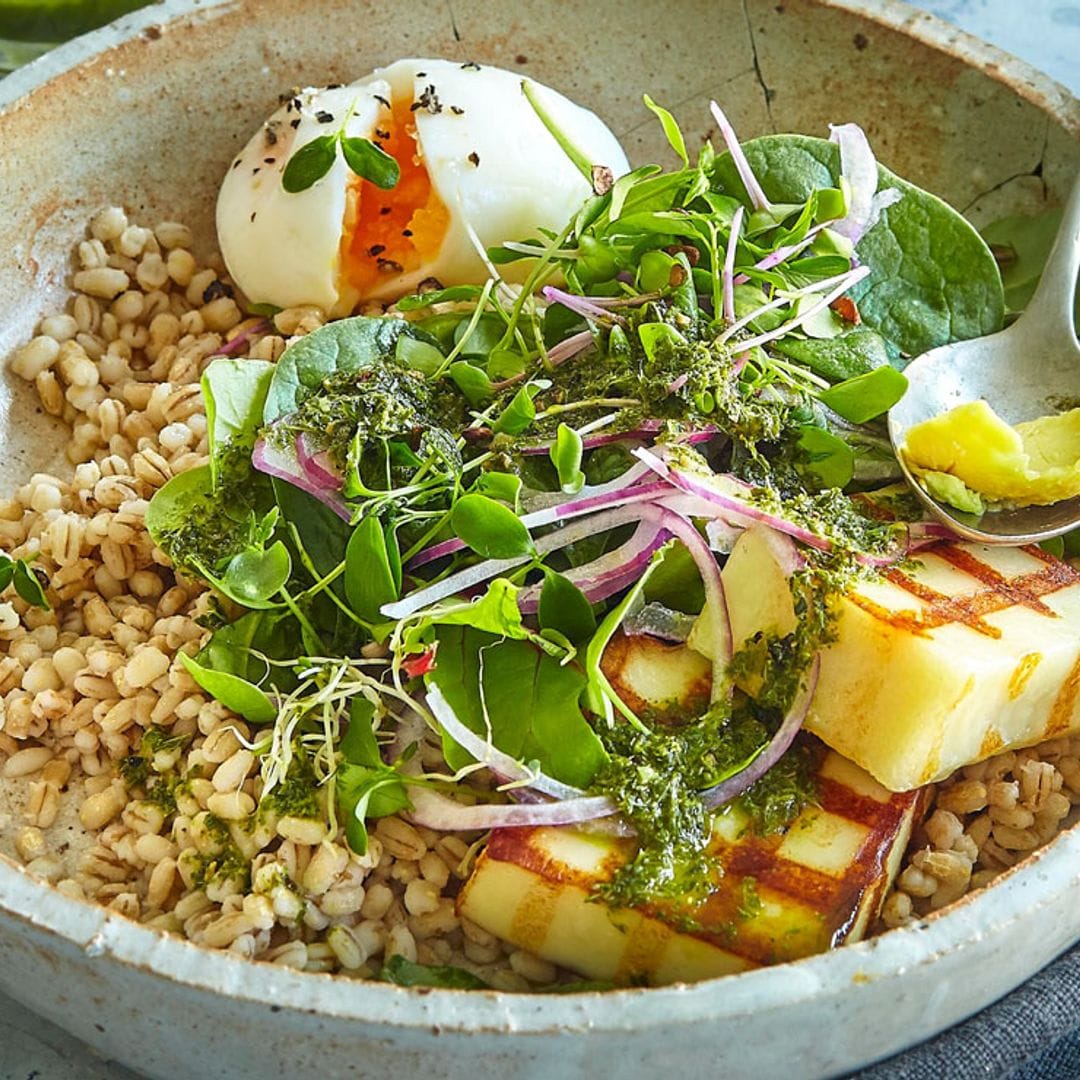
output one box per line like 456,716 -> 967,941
458,753 -> 921,985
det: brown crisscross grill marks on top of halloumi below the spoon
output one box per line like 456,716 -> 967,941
849,543 -> 1080,638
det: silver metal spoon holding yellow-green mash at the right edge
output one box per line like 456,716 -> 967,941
889,177 -> 1080,544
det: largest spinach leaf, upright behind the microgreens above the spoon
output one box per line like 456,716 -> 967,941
714,135 -> 1004,355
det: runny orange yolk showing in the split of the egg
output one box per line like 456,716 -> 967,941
341,100 -> 449,298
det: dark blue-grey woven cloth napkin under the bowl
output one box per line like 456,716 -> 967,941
849,945 -> 1080,1080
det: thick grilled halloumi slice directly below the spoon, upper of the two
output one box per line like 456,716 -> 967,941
708,528 -> 1080,792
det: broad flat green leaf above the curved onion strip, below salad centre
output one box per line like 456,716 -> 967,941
426,626 -> 607,786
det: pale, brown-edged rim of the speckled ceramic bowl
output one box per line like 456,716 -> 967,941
0,0 -> 1080,1037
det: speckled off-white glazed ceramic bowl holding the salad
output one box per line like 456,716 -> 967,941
0,0 -> 1080,1080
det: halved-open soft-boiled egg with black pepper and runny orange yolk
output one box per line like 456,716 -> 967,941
217,59 -> 629,315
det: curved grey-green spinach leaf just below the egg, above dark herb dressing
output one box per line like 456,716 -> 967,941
262,315 -> 438,423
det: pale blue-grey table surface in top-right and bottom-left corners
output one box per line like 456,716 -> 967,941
0,0 -> 1080,1080
